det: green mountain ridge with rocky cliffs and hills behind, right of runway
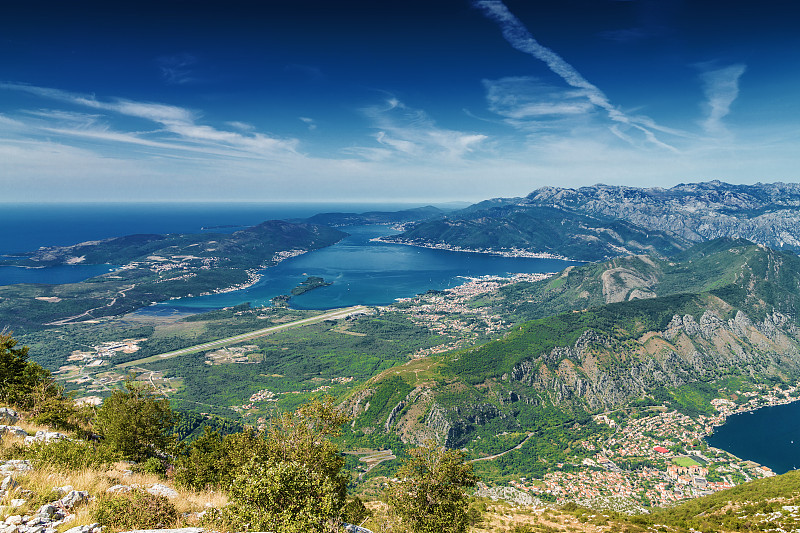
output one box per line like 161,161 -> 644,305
349,240 -> 800,454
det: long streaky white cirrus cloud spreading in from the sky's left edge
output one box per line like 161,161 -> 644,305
0,83 -> 298,157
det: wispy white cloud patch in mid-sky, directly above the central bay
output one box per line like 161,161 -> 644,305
362,97 -> 488,162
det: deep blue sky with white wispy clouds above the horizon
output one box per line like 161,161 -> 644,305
0,0 -> 800,202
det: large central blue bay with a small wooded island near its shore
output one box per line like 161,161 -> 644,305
151,226 -> 575,312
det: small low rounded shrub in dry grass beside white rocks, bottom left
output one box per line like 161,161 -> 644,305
94,490 -> 178,531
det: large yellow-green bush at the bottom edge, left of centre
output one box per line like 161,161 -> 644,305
206,398 -> 354,533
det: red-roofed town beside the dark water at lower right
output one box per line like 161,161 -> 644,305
500,386 -> 799,513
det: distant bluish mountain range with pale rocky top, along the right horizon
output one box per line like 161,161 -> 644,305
390,181 -> 800,261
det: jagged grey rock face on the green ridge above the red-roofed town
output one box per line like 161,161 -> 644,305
502,309 -> 800,409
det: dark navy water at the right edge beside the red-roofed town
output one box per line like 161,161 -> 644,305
706,402 -> 800,474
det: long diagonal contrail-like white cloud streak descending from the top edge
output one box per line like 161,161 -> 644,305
474,0 -> 677,152
